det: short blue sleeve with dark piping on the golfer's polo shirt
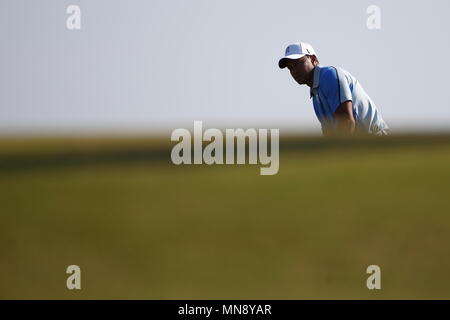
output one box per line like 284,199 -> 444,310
320,67 -> 352,113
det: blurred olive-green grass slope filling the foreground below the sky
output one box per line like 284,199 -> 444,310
0,135 -> 450,299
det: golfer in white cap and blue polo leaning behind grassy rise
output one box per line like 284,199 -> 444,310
278,42 -> 389,135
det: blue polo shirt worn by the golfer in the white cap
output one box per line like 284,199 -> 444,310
311,65 -> 389,135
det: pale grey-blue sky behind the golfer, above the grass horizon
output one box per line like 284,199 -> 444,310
0,0 -> 450,134
